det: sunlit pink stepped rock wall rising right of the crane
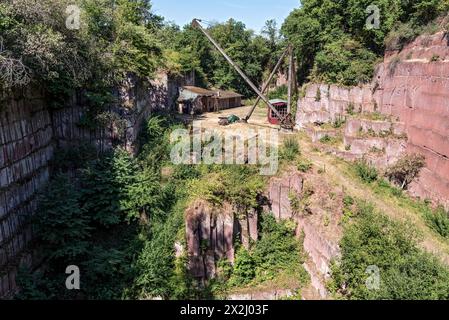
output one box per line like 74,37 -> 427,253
297,32 -> 449,206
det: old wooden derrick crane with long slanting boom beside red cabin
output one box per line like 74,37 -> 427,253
192,19 -> 294,130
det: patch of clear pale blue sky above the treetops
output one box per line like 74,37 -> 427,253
152,0 -> 299,32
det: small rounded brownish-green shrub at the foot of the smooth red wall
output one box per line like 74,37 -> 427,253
386,154 -> 426,190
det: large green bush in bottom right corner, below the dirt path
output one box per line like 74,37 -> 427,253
329,205 -> 449,300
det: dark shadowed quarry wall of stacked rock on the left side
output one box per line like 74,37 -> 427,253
0,75 -> 178,298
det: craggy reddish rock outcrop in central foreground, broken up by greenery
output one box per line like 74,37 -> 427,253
185,171 -> 343,300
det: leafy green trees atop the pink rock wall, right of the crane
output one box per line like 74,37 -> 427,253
281,0 -> 449,85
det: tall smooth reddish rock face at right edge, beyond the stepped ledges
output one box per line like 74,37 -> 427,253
378,32 -> 449,205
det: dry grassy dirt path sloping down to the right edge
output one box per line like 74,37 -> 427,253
301,139 -> 449,265
